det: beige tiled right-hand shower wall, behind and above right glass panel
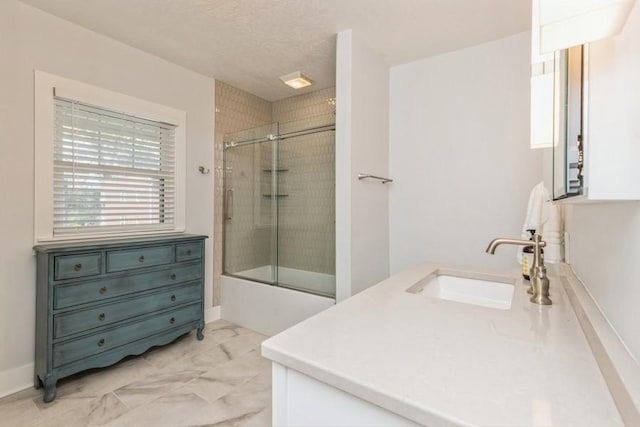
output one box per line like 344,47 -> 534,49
272,88 -> 335,276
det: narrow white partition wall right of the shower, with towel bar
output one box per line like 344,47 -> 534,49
336,30 -> 390,301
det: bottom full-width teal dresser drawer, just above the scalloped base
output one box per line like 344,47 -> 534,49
53,304 -> 202,367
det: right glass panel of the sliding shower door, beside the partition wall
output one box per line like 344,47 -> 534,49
277,114 -> 335,297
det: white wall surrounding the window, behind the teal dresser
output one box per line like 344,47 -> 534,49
0,0 -> 214,395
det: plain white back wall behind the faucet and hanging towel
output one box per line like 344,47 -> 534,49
389,33 -> 542,273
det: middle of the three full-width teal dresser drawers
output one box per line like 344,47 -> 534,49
53,283 -> 201,338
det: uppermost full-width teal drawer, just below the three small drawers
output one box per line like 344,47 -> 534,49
53,262 -> 202,309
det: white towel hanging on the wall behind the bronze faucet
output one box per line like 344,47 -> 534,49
517,182 -> 563,264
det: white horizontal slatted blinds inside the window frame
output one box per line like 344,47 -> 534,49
53,97 -> 176,236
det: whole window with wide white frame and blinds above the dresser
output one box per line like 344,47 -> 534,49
35,72 -> 185,242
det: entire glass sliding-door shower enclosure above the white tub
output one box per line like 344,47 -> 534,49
223,114 -> 335,298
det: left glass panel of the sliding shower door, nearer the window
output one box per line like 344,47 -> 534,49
223,125 -> 278,284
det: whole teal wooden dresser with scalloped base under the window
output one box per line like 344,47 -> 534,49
35,234 -> 206,402
